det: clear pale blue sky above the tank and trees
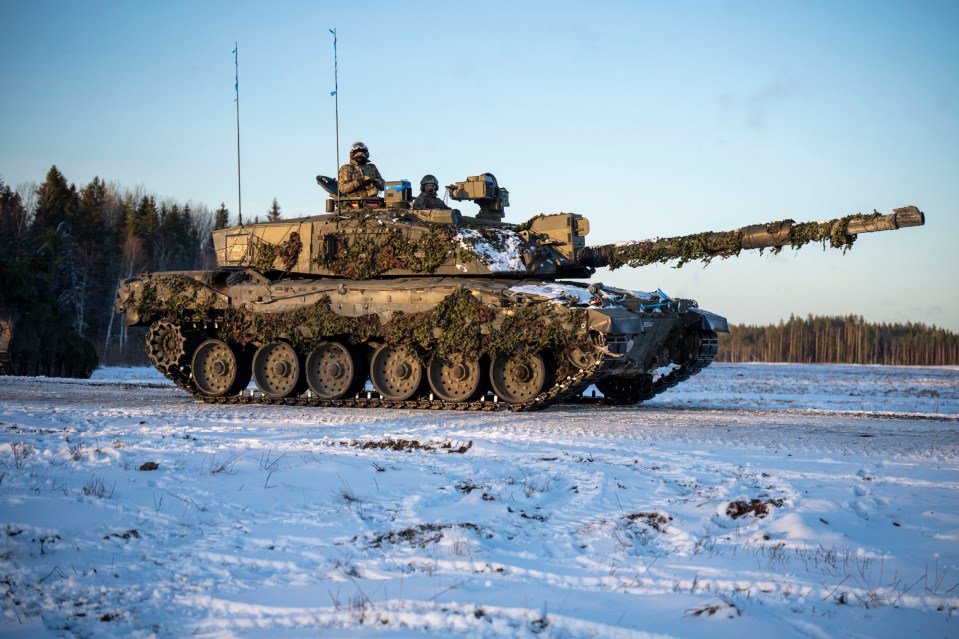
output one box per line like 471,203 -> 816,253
0,0 -> 959,331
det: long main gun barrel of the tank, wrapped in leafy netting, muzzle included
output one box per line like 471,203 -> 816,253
576,206 -> 926,269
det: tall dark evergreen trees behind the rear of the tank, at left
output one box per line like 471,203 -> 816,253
0,166 -> 281,376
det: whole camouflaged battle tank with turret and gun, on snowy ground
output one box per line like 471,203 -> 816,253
110,173 -> 924,410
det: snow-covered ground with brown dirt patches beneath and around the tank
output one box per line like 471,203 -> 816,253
0,364 -> 959,639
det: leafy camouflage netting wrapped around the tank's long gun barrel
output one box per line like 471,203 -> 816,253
600,213 -> 879,269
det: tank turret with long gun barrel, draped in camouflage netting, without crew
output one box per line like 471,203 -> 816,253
213,178 -> 925,279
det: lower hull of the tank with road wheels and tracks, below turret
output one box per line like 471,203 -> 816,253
116,269 -> 727,410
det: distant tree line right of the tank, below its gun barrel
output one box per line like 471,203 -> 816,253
715,315 -> 959,366
